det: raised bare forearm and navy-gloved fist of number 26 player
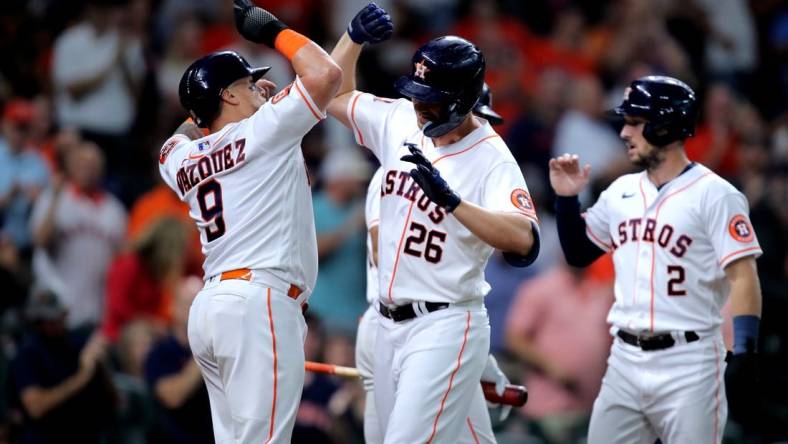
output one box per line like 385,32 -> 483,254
328,3 -> 394,128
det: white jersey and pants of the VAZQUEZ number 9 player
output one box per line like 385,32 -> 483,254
160,77 -> 325,443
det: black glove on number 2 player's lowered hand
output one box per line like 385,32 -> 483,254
725,352 -> 761,429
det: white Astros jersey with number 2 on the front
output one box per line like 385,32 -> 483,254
585,164 -> 761,332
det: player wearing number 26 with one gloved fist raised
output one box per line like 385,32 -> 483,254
329,4 -> 538,444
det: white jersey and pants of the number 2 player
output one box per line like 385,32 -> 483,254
585,164 -> 761,444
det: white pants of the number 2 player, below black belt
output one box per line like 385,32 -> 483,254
588,334 -> 728,444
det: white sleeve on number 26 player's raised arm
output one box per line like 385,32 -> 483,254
347,91 -> 417,159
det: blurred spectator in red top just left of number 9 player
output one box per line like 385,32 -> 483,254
101,217 -> 191,342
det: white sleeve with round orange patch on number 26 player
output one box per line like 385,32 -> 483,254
480,162 -> 539,225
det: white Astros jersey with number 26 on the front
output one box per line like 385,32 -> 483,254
347,92 -> 537,305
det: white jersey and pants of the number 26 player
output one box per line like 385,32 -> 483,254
347,93 -> 537,444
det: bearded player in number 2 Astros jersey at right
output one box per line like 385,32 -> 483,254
550,76 -> 761,444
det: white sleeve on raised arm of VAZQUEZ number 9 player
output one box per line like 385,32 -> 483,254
246,76 -> 326,155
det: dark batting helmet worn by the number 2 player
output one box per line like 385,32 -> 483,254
612,76 -> 698,146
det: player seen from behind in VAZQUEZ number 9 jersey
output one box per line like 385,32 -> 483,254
160,0 -> 341,443
